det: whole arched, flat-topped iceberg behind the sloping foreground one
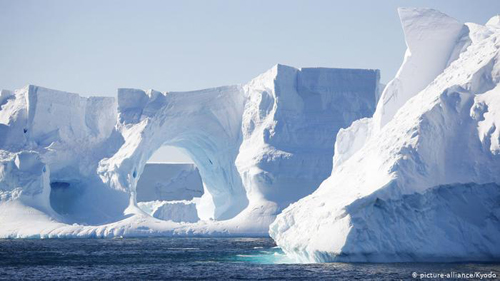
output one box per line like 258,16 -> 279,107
0,62 -> 379,237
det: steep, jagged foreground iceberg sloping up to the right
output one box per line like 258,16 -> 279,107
270,8 -> 500,262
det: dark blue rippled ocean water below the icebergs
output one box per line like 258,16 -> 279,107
0,238 -> 500,280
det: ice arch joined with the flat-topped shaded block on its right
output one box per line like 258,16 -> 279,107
99,65 -> 379,221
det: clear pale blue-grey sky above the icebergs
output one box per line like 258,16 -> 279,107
0,0 -> 500,161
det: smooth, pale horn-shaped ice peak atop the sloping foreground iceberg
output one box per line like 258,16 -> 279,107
374,8 -> 468,129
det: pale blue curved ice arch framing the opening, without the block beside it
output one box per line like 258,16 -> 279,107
100,86 -> 248,219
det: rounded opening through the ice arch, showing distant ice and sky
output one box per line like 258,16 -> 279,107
136,145 -> 214,223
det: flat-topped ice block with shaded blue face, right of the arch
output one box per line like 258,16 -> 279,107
236,65 -> 379,210
